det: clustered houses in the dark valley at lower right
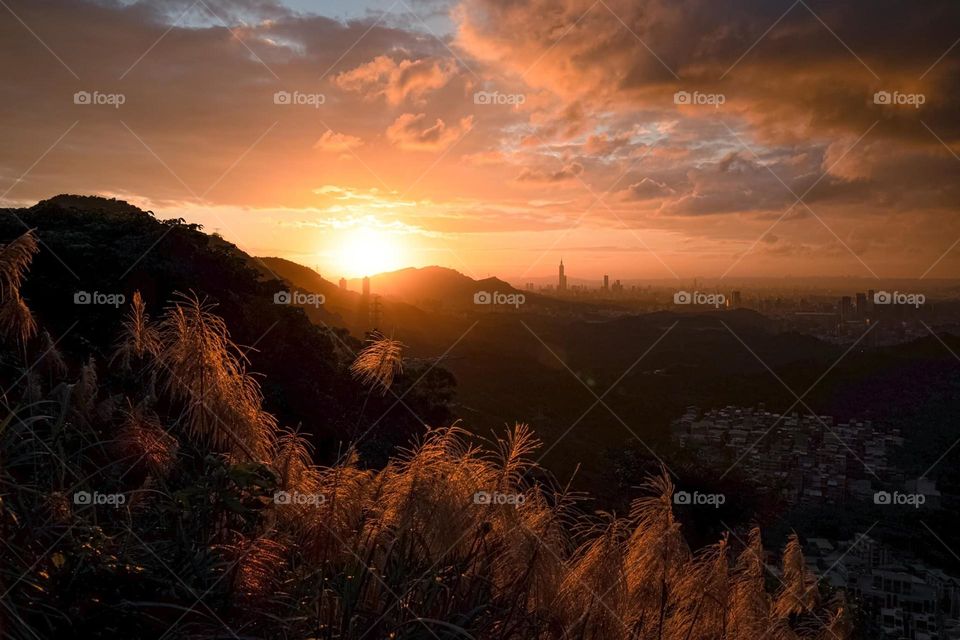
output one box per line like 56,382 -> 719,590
671,404 -> 960,640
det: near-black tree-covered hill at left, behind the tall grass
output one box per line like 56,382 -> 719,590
0,195 -> 449,459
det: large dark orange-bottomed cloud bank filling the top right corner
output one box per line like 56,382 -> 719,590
457,0 -> 960,142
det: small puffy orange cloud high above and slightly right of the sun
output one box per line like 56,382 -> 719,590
334,56 -> 457,105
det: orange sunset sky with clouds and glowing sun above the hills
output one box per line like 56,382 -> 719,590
0,0 -> 960,282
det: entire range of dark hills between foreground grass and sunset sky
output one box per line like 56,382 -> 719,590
9,196 -> 960,496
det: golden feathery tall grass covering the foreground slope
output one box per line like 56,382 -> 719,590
0,232 -> 850,640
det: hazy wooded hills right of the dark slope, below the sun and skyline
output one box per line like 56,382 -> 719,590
249,255 -> 957,492
